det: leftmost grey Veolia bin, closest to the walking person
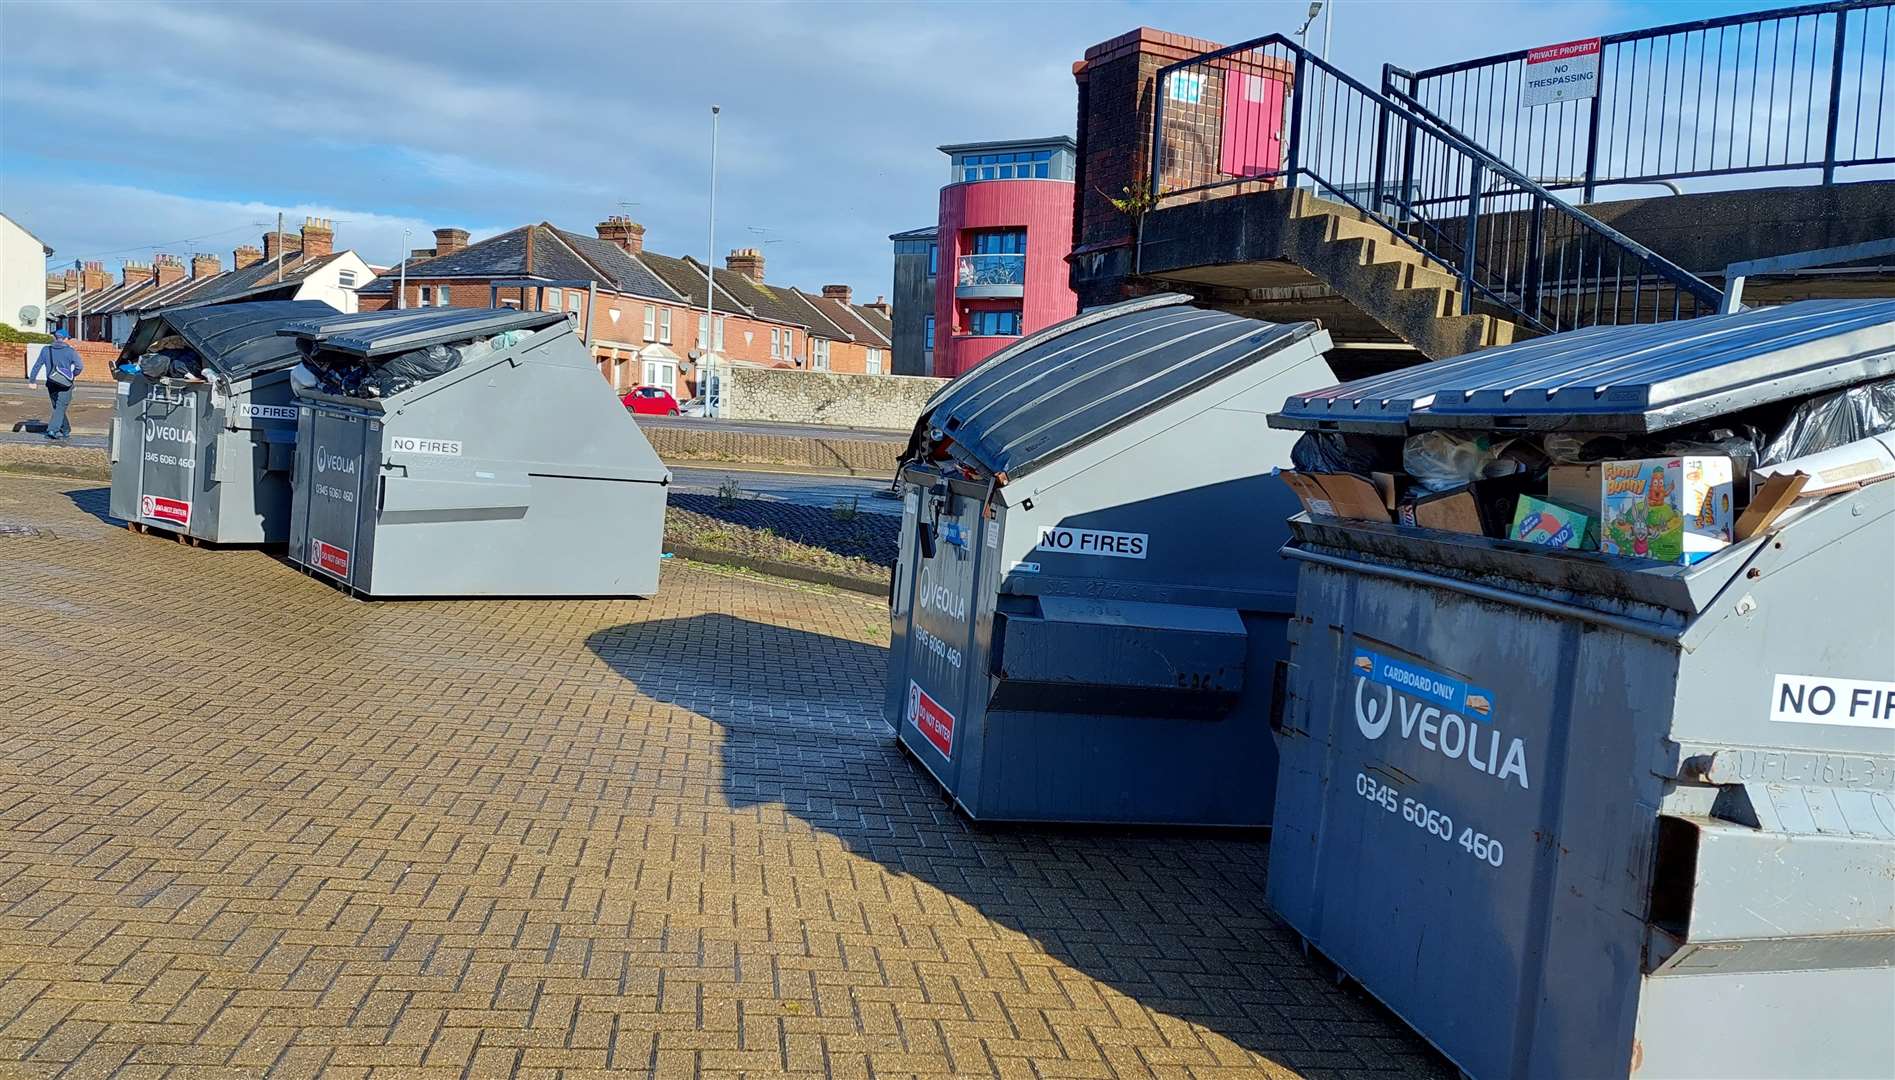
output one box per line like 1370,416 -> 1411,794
106,299 -> 335,544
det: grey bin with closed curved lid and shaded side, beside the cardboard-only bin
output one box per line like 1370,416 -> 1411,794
885,296 -> 1334,826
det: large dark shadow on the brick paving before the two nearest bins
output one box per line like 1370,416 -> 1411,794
587,614 -> 1452,1076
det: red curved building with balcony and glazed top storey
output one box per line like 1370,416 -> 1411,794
929,136 -> 1078,379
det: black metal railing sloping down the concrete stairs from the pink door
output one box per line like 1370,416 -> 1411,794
1148,34 -> 1723,333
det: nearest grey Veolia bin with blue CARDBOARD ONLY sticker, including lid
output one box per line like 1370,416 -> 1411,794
1268,301 -> 1895,1078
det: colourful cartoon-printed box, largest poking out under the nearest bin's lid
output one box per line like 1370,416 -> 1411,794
1599,457 -> 1734,567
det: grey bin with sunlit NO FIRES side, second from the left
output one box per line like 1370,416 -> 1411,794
286,307 -> 671,597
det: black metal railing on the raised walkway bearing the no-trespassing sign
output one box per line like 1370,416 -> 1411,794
1381,0 -> 1895,201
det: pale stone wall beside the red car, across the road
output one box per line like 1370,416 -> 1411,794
720,368 -> 948,432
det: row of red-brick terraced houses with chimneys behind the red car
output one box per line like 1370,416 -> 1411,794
358,214 -> 891,400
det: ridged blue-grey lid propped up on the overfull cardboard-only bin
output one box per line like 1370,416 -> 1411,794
1270,299 -> 1895,434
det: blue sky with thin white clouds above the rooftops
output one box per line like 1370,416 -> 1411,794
0,0 -> 1776,297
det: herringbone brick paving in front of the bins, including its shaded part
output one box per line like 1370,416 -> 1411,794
0,477 -> 1444,1078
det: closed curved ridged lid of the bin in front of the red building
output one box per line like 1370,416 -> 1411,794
910,294 -> 1319,479
